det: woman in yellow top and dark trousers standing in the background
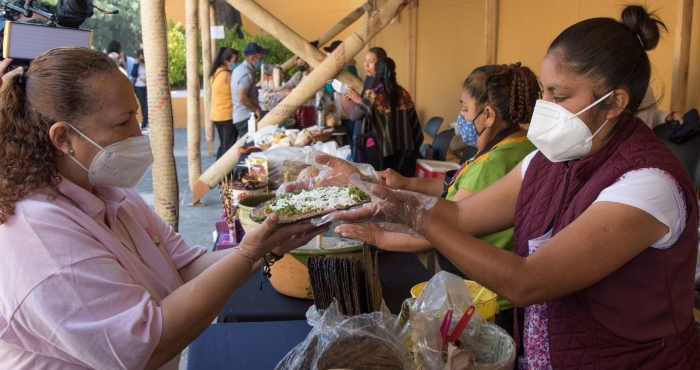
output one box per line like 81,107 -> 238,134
209,47 -> 238,159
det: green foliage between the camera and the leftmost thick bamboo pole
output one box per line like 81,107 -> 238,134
80,0 -> 143,57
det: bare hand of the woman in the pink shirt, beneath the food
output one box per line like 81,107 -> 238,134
240,213 -> 329,260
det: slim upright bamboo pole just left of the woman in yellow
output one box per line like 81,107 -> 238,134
200,0 -> 216,158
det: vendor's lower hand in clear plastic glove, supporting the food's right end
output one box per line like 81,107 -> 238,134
311,175 -> 438,238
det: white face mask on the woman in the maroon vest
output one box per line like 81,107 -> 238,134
527,90 -> 615,162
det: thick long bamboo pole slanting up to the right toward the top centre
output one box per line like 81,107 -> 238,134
192,0 -> 410,201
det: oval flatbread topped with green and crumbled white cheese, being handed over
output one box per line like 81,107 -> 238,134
250,186 -> 370,224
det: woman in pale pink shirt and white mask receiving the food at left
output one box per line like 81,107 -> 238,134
0,48 -> 324,369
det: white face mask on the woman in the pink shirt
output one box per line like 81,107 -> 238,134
69,124 -> 153,188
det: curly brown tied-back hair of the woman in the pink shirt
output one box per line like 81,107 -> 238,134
0,47 -> 117,224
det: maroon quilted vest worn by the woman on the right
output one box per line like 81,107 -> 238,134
514,118 -> 700,369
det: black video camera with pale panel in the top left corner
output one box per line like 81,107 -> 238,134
0,0 -> 94,69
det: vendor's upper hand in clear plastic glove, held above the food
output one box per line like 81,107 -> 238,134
277,154 -> 380,196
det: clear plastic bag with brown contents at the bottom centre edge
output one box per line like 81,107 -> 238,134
275,302 -> 414,370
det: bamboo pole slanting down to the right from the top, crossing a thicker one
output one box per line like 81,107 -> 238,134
227,0 -> 364,91
